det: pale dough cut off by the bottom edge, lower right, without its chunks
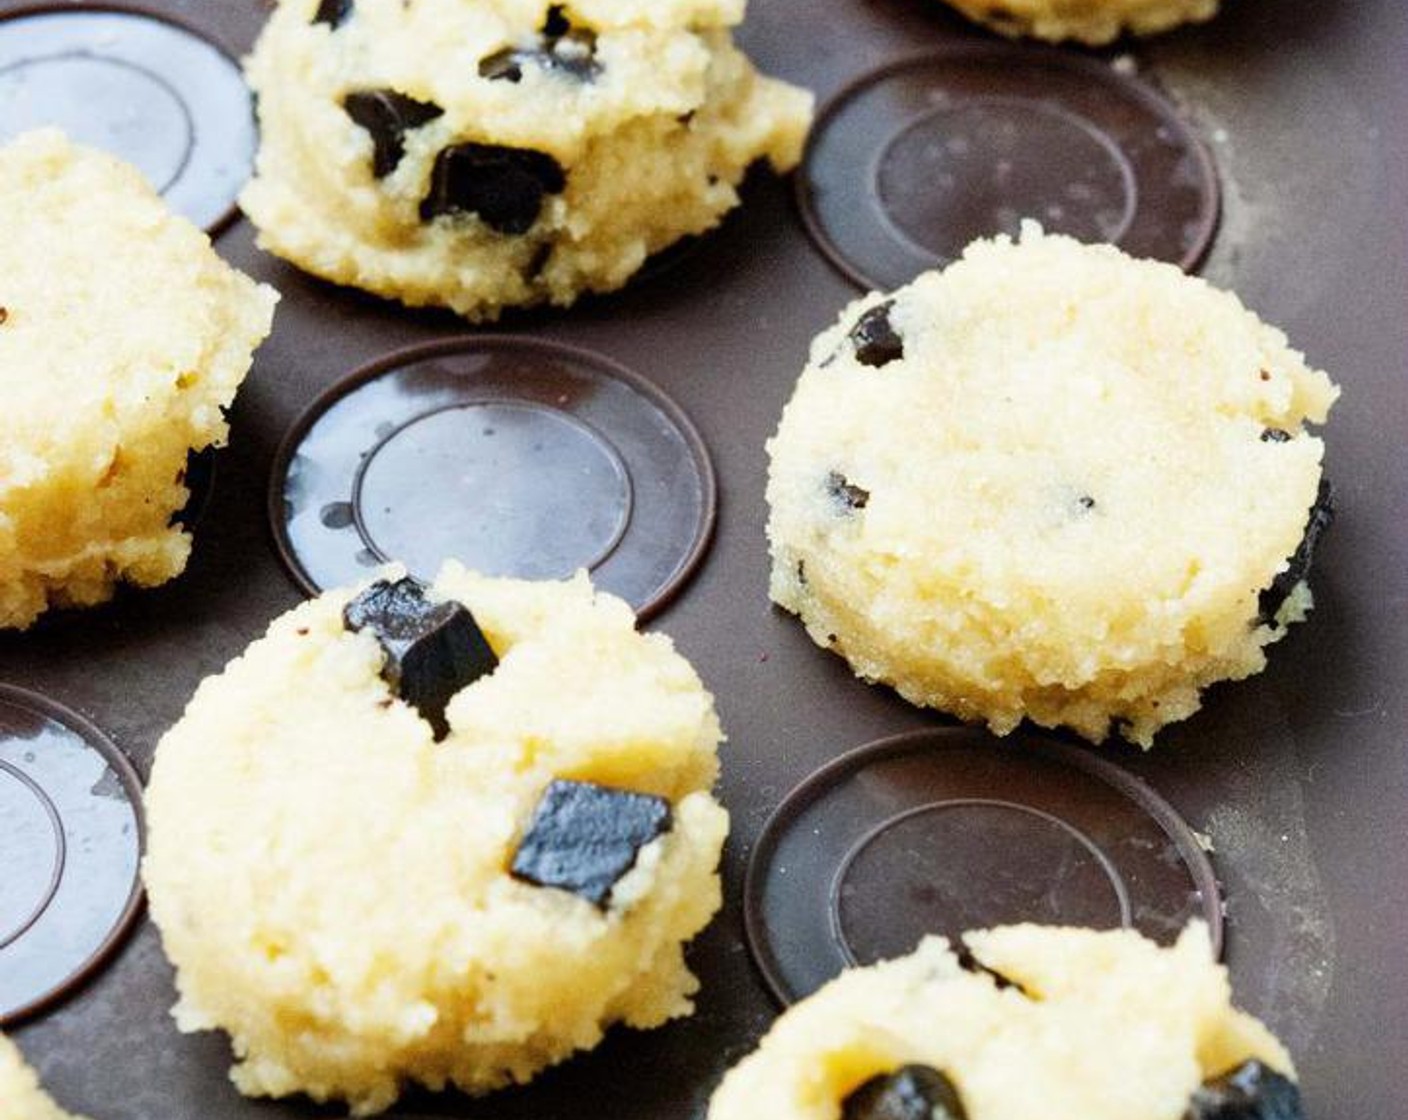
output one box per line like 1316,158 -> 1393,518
708,926 -> 1294,1120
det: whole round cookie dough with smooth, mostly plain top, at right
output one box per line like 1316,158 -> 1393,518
767,225 -> 1338,745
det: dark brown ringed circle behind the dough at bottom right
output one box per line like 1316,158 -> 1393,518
743,727 -> 1222,1003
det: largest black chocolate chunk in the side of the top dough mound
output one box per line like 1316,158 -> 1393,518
421,144 -> 567,234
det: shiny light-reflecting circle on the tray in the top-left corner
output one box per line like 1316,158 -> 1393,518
0,4 -> 256,231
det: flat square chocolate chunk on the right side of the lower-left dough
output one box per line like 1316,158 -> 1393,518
511,779 -> 670,910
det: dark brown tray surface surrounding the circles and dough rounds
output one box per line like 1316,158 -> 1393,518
0,0 -> 1408,1120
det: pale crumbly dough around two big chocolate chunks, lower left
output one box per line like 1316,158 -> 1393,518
145,565 -> 728,1114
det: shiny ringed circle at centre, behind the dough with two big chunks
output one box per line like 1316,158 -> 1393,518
269,337 -> 717,616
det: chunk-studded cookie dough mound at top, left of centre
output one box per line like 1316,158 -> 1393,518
241,0 -> 812,320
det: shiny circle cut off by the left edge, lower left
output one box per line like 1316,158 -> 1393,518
0,685 -> 142,1026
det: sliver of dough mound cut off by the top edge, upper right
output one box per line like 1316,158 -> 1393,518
948,0 -> 1218,46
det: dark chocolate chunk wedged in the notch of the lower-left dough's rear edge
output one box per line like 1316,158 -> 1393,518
342,576 -> 498,740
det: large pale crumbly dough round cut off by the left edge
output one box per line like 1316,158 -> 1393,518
0,131 -> 277,627
